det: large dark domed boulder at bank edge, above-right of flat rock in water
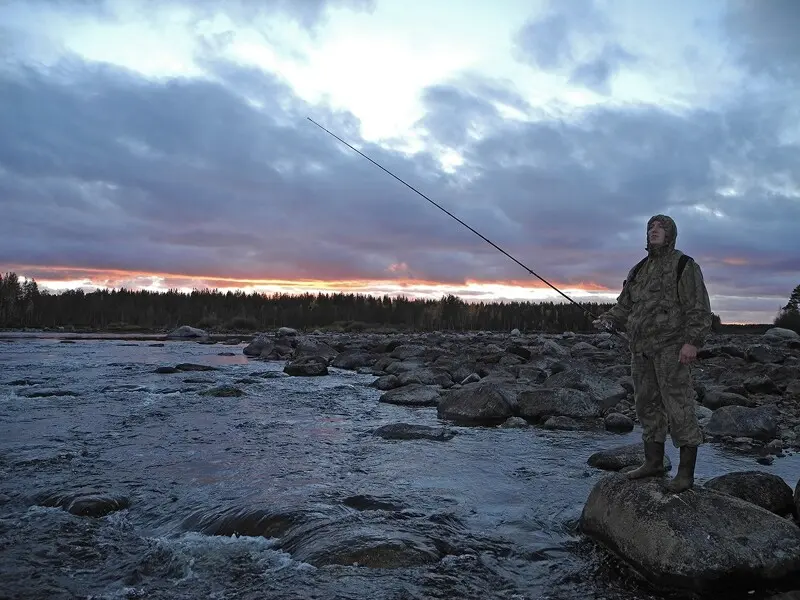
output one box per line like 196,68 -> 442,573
437,381 -> 515,425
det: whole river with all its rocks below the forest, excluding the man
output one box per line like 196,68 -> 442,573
0,328 -> 800,600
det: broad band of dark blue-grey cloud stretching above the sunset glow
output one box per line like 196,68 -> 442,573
0,35 -> 800,324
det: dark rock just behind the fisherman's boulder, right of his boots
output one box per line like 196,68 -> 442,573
703,471 -> 794,516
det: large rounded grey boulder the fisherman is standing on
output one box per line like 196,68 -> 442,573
580,474 -> 800,593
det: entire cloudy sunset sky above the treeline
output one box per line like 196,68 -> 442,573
0,0 -> 800,323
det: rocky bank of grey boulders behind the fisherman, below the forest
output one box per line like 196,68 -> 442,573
243,328 -> 800,463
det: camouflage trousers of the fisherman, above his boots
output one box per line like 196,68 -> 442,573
631,346 -> 703,448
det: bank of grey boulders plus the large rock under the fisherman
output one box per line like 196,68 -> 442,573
243,328 -> 800,591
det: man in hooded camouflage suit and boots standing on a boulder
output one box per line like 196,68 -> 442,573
594,215 -> 712,493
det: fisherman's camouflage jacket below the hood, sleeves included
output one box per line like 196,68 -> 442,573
600,248 -> 712,352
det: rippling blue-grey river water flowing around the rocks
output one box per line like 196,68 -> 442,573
0,336 -> 800,600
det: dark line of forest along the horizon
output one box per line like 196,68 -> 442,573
0,272 -> 800,333
